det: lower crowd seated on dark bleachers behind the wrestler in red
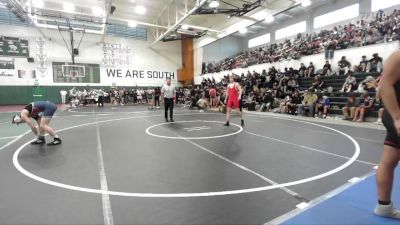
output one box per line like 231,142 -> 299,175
197,50 -> 382,122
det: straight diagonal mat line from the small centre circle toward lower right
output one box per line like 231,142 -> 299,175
141,115 -> 304,199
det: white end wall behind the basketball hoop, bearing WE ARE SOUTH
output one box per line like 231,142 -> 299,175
0,25 -> 181,87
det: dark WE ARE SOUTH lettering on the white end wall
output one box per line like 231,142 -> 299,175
100,68 -> 178,86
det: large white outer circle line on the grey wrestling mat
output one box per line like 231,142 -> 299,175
12,113 -> 360,198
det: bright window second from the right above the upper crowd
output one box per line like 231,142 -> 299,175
314,4 -> 360,28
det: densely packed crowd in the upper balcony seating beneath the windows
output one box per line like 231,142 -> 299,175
202,10 -> 400,74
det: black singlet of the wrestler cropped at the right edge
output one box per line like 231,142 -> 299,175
382,81 -> 400,149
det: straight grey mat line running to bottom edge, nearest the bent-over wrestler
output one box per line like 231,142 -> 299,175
93,108 -> 114,225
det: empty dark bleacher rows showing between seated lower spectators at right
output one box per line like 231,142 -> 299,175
299,73 -> 380,117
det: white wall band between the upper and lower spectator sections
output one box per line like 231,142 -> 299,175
195,42 -> 400,84
